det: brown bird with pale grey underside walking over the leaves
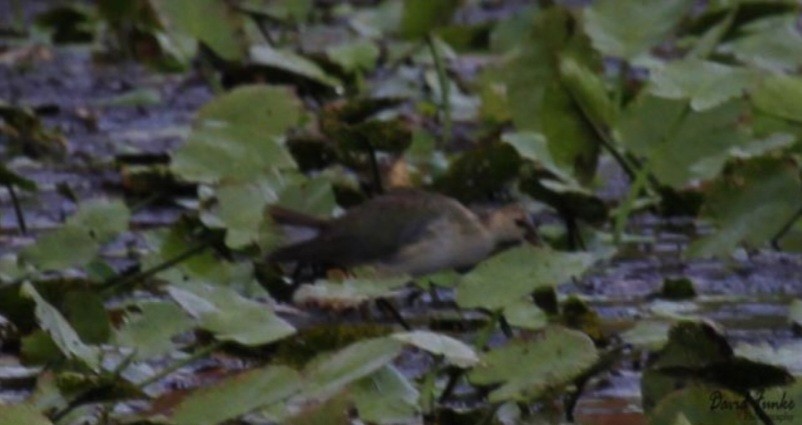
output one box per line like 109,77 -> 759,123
268,189 -> 535,277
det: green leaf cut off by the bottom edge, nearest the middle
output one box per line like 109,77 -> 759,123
348,365 -> 419,424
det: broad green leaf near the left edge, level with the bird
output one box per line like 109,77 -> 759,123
20,200 -> 130,270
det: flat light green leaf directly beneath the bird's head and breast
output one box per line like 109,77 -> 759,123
456,245 -> 595,310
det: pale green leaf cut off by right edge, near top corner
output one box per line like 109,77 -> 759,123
719,13 -> 802,72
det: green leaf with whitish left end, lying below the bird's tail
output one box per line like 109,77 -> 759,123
167,282 -> 295,345
